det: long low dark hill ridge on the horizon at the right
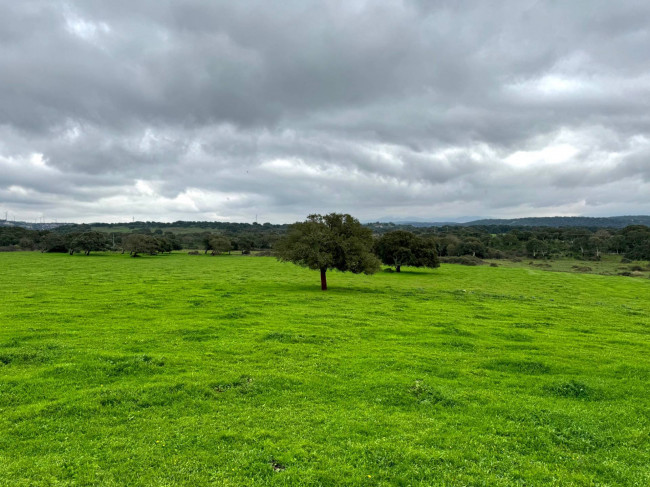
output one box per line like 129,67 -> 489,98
461,215 -> 650,228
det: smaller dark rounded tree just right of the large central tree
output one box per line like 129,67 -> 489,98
375,230 -> 440,272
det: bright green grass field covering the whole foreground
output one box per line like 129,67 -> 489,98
0,253 -> 650,486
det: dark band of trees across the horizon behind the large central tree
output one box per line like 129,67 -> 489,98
0,222 -> 650,264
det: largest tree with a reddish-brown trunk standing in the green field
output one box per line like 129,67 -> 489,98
275,213 -> 380,291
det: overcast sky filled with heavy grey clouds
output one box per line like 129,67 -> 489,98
0,0 -> 650,223
